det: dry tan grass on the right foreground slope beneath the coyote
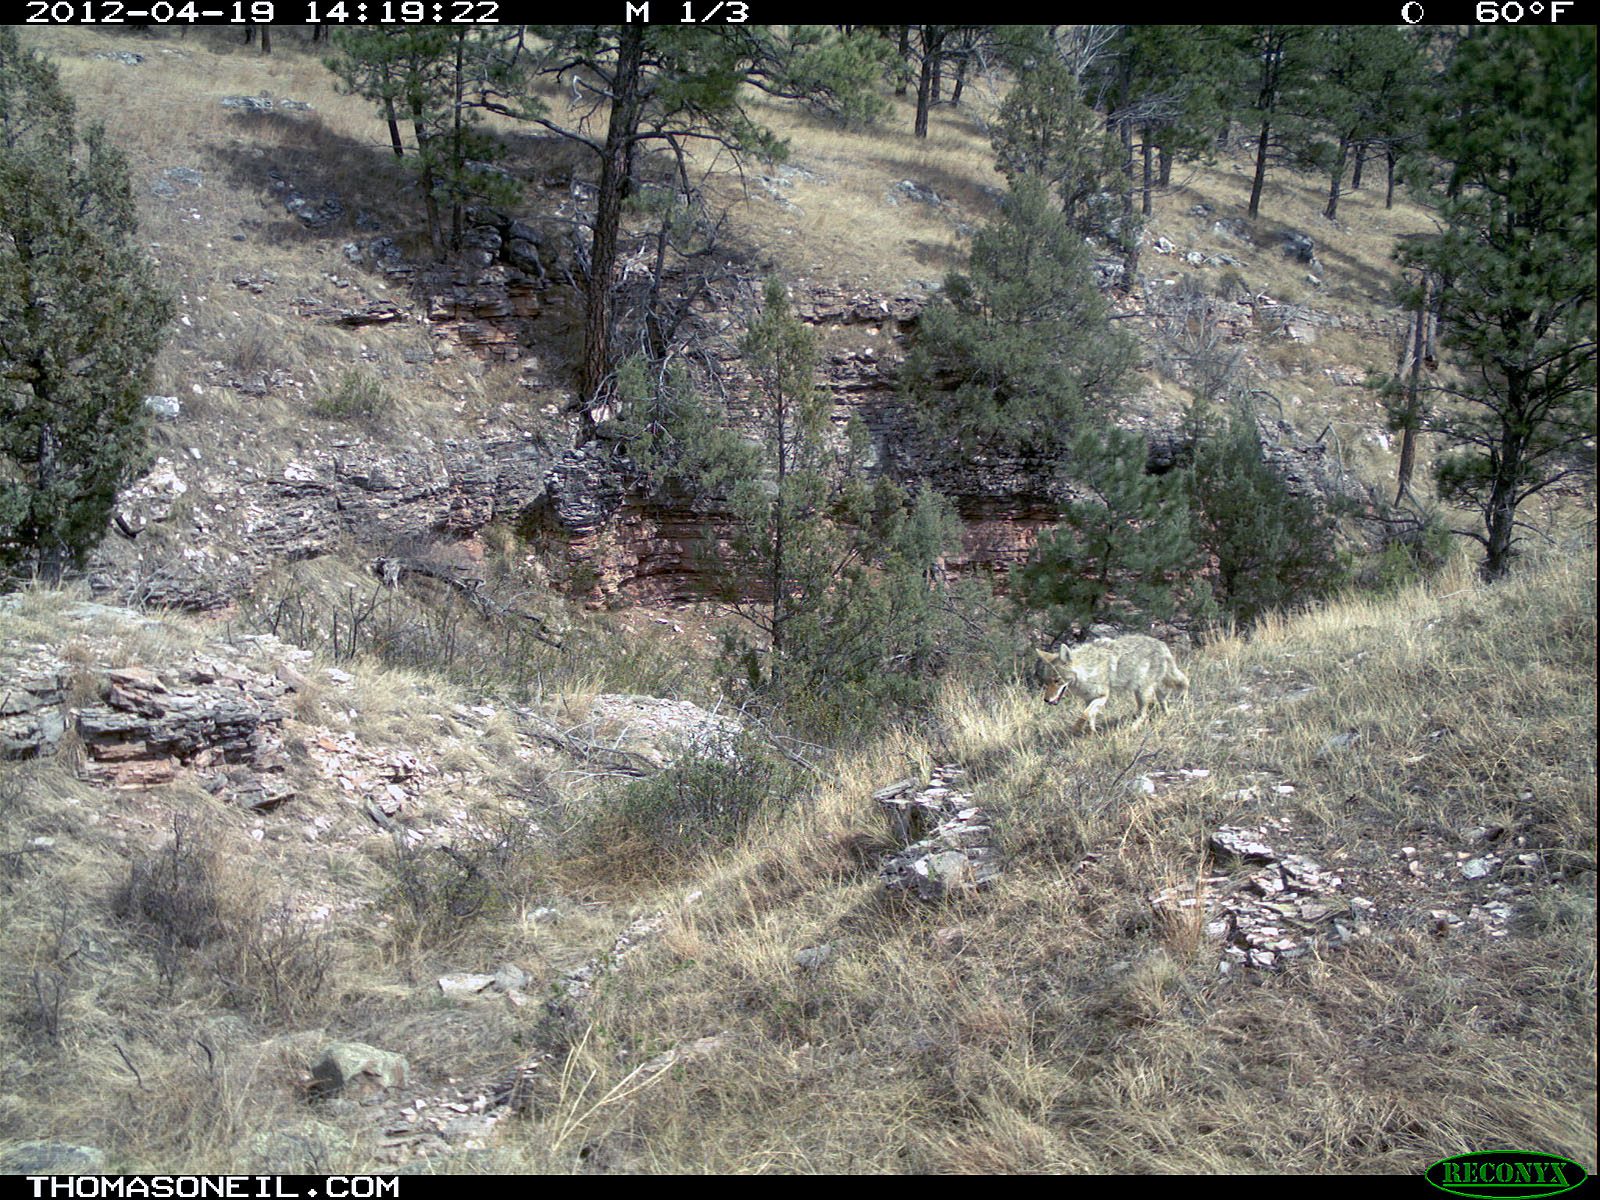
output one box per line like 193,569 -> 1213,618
483,560 -> 1595,1173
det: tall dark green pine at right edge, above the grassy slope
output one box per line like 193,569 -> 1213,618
1402,26 -> 1595,579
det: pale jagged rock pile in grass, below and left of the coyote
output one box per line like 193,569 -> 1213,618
872,763 -> 1002,901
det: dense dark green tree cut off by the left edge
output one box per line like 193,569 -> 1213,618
0,27 -> 171,581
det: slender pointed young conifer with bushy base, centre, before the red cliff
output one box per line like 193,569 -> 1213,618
616,280 -> 960,734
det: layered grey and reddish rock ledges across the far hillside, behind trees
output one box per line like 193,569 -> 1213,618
90,272 -> 1347,611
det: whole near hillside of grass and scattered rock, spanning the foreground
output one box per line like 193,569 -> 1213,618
0,555 -> 1595,1173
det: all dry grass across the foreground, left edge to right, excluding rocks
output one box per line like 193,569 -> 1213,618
0,554 -> 1595,1173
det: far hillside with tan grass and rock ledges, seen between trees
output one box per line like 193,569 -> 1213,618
12,29 -> 1429,611
